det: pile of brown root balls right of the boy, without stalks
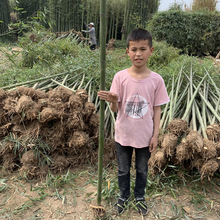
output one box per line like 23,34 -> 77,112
149,119 -> 220,179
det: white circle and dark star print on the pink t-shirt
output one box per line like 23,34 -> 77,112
125,93 -> 148,119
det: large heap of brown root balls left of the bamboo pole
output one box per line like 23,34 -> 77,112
0,86 -> 114,179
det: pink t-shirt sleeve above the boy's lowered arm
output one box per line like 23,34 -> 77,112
154,77 -> 170,106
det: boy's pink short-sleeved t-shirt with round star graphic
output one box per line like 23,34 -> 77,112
110,69 -> 170,148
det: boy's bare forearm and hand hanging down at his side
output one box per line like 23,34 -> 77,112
149,105 -> 161,152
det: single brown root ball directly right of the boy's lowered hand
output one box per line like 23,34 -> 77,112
161,133 -> 178,156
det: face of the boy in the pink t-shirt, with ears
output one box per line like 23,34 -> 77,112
126,40 -> 154,68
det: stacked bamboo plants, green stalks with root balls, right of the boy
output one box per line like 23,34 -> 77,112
149,63 -> 220,179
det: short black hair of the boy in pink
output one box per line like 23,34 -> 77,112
127,28 -> 152,48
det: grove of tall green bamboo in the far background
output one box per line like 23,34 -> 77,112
0,0 -> 160,40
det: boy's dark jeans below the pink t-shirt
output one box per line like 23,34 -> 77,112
115,142 -> 151,199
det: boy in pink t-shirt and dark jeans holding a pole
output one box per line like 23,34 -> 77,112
98,28 -> 169,215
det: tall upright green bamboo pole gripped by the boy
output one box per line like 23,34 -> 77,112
97,0 -> 106,205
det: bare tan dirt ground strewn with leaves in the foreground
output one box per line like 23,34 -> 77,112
0,167 -> 220,220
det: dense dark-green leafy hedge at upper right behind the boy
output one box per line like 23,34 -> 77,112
148,10 -> 220,56
